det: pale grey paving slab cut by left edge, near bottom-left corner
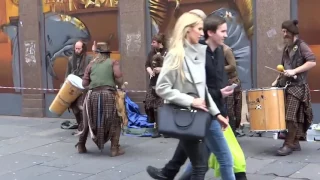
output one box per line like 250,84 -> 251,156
0,153 -> 54,175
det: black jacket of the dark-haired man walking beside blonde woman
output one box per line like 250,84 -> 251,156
199,40 -> 228,117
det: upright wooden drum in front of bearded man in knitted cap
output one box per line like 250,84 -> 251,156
247,87 -> 286,131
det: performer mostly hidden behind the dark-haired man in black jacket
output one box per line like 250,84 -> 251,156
223,44 -> 242,134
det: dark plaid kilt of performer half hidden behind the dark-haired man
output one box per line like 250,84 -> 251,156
226,85 -> 242,128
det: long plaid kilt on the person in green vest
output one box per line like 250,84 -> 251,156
87,89 -> 121,150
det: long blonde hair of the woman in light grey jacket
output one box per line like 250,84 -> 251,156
166,12 -> 203,79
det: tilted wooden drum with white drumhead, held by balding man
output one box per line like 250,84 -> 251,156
49,74 -> 84,116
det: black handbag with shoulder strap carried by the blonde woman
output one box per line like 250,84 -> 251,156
158,60 -> 212,140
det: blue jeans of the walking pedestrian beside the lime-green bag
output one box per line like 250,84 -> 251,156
181,120 -> 236,180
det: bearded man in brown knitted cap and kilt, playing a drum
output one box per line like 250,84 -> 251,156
272,20 -> 316,156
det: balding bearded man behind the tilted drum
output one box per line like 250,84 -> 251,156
65,41 -> 92,131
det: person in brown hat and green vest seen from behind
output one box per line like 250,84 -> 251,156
76,42 -> 125,157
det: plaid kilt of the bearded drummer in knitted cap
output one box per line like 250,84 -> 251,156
286,84 -> 313,134
